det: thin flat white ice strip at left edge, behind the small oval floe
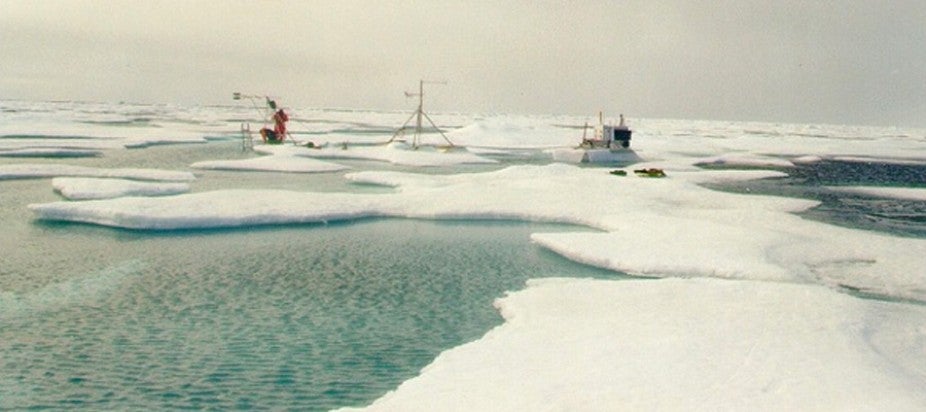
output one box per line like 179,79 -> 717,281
0,163 -> 196,182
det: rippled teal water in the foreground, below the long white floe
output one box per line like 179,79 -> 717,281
0,220 -> 615,409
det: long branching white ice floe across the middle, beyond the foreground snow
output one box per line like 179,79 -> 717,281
30,164 -> 926,300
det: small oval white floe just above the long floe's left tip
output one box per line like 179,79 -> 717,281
51,177 -> 190,200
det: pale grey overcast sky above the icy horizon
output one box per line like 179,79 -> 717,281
0,0 -> 926,126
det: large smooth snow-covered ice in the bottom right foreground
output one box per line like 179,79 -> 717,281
338,279 -> 926,411
